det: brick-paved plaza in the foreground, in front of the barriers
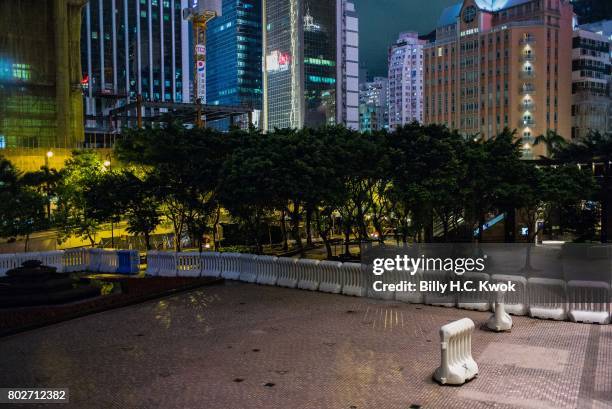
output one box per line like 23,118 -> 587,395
0,282 -> 612,409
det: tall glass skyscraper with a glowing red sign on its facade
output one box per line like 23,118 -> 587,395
262,0 -> 359,130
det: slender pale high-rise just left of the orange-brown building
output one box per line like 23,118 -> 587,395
389,32 -> 425,129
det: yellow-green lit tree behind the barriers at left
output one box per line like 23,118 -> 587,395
55,150 -> 106,247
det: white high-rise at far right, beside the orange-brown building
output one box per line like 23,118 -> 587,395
572,21 -> 612,138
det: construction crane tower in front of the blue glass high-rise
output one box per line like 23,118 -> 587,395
183,0 -> 221,128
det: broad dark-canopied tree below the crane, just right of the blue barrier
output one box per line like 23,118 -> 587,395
116,121 -> 232,251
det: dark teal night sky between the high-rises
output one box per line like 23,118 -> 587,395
355,0 -> 459,77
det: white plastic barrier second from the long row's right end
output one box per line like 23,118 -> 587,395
527,278 -> 567,321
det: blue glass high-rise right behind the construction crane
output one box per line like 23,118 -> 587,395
206,0 -> 262,110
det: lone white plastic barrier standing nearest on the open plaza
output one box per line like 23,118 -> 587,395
434,318 -> 478,385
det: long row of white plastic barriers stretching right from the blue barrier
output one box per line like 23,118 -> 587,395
147,251 -> 612,324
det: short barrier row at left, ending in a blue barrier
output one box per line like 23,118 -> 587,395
0,248 -> 140,277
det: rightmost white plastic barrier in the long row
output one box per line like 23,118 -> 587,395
567,280 -> 611,324
